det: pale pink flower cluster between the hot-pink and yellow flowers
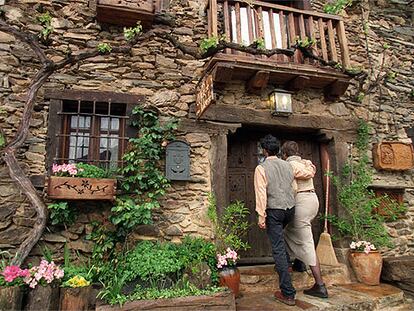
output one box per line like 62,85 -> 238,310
24,259 -> 65,288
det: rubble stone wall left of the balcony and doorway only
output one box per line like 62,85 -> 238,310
0,0 -> 212,255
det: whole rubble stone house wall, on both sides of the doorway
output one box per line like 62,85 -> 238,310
0,0 -> 414,255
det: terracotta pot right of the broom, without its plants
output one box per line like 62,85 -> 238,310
349,251 -> 382,285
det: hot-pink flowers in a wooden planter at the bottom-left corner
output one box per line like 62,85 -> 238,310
0,252 -> 29,311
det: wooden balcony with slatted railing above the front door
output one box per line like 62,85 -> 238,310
206,0 -> 349,96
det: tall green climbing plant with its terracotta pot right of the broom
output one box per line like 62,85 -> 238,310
328,121 -> 404,285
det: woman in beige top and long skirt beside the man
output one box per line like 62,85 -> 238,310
281,141 -> 328,298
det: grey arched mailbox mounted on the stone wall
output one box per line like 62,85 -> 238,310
165,141 -> 190,180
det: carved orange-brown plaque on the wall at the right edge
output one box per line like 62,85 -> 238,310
372,142 -> 414,171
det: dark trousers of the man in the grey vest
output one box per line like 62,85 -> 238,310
266,207 -> 296,298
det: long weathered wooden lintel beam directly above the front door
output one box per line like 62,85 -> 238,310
190,104 -> 358,134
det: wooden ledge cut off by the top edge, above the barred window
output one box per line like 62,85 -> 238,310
96,0 -> 165,27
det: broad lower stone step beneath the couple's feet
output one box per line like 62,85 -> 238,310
236,283 -> 408,311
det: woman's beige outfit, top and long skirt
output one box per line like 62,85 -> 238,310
285,156 -> 319,266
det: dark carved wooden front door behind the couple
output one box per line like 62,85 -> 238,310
227,131 -> 324,264
